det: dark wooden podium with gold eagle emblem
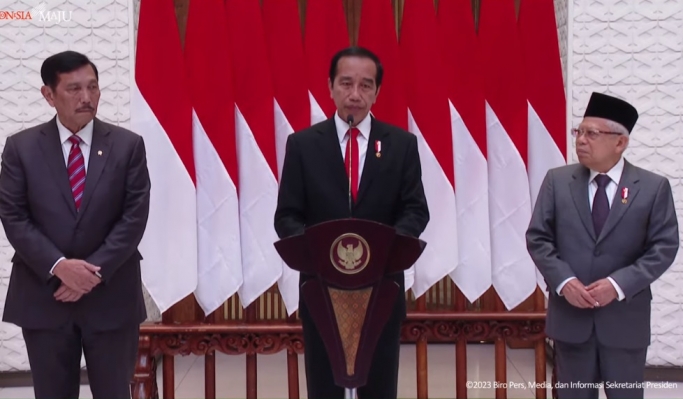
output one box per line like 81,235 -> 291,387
275,219 -> 426,397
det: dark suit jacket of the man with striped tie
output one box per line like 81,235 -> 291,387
0,119 -> 150,331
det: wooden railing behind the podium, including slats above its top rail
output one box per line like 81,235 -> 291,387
132,279 -> 554,399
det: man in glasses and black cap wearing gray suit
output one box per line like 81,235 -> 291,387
527,93 -> 679,399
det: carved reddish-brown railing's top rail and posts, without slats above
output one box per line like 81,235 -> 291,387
131,312 -> 554,399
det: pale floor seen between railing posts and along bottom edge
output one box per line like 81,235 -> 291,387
0,345 -> 683,399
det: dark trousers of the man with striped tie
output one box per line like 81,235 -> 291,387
22,324 -> 140,399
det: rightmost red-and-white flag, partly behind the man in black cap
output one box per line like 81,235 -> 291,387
518,0 -> 567,295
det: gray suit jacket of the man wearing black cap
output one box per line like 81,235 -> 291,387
526,162 -> 679,348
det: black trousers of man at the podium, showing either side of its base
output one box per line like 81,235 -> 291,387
299,292 -> 405,399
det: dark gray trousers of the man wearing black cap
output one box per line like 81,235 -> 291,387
554,331 -> 647,399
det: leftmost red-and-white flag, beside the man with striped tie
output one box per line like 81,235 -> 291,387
131,0 -> 197,312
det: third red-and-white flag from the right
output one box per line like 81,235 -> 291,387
438,0 -> 491,302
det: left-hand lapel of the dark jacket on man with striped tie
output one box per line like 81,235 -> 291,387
40,117 -> 76,217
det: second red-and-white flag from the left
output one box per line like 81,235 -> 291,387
185,0 -> 242,315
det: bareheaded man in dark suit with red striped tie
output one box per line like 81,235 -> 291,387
0,51 -> 150,398
